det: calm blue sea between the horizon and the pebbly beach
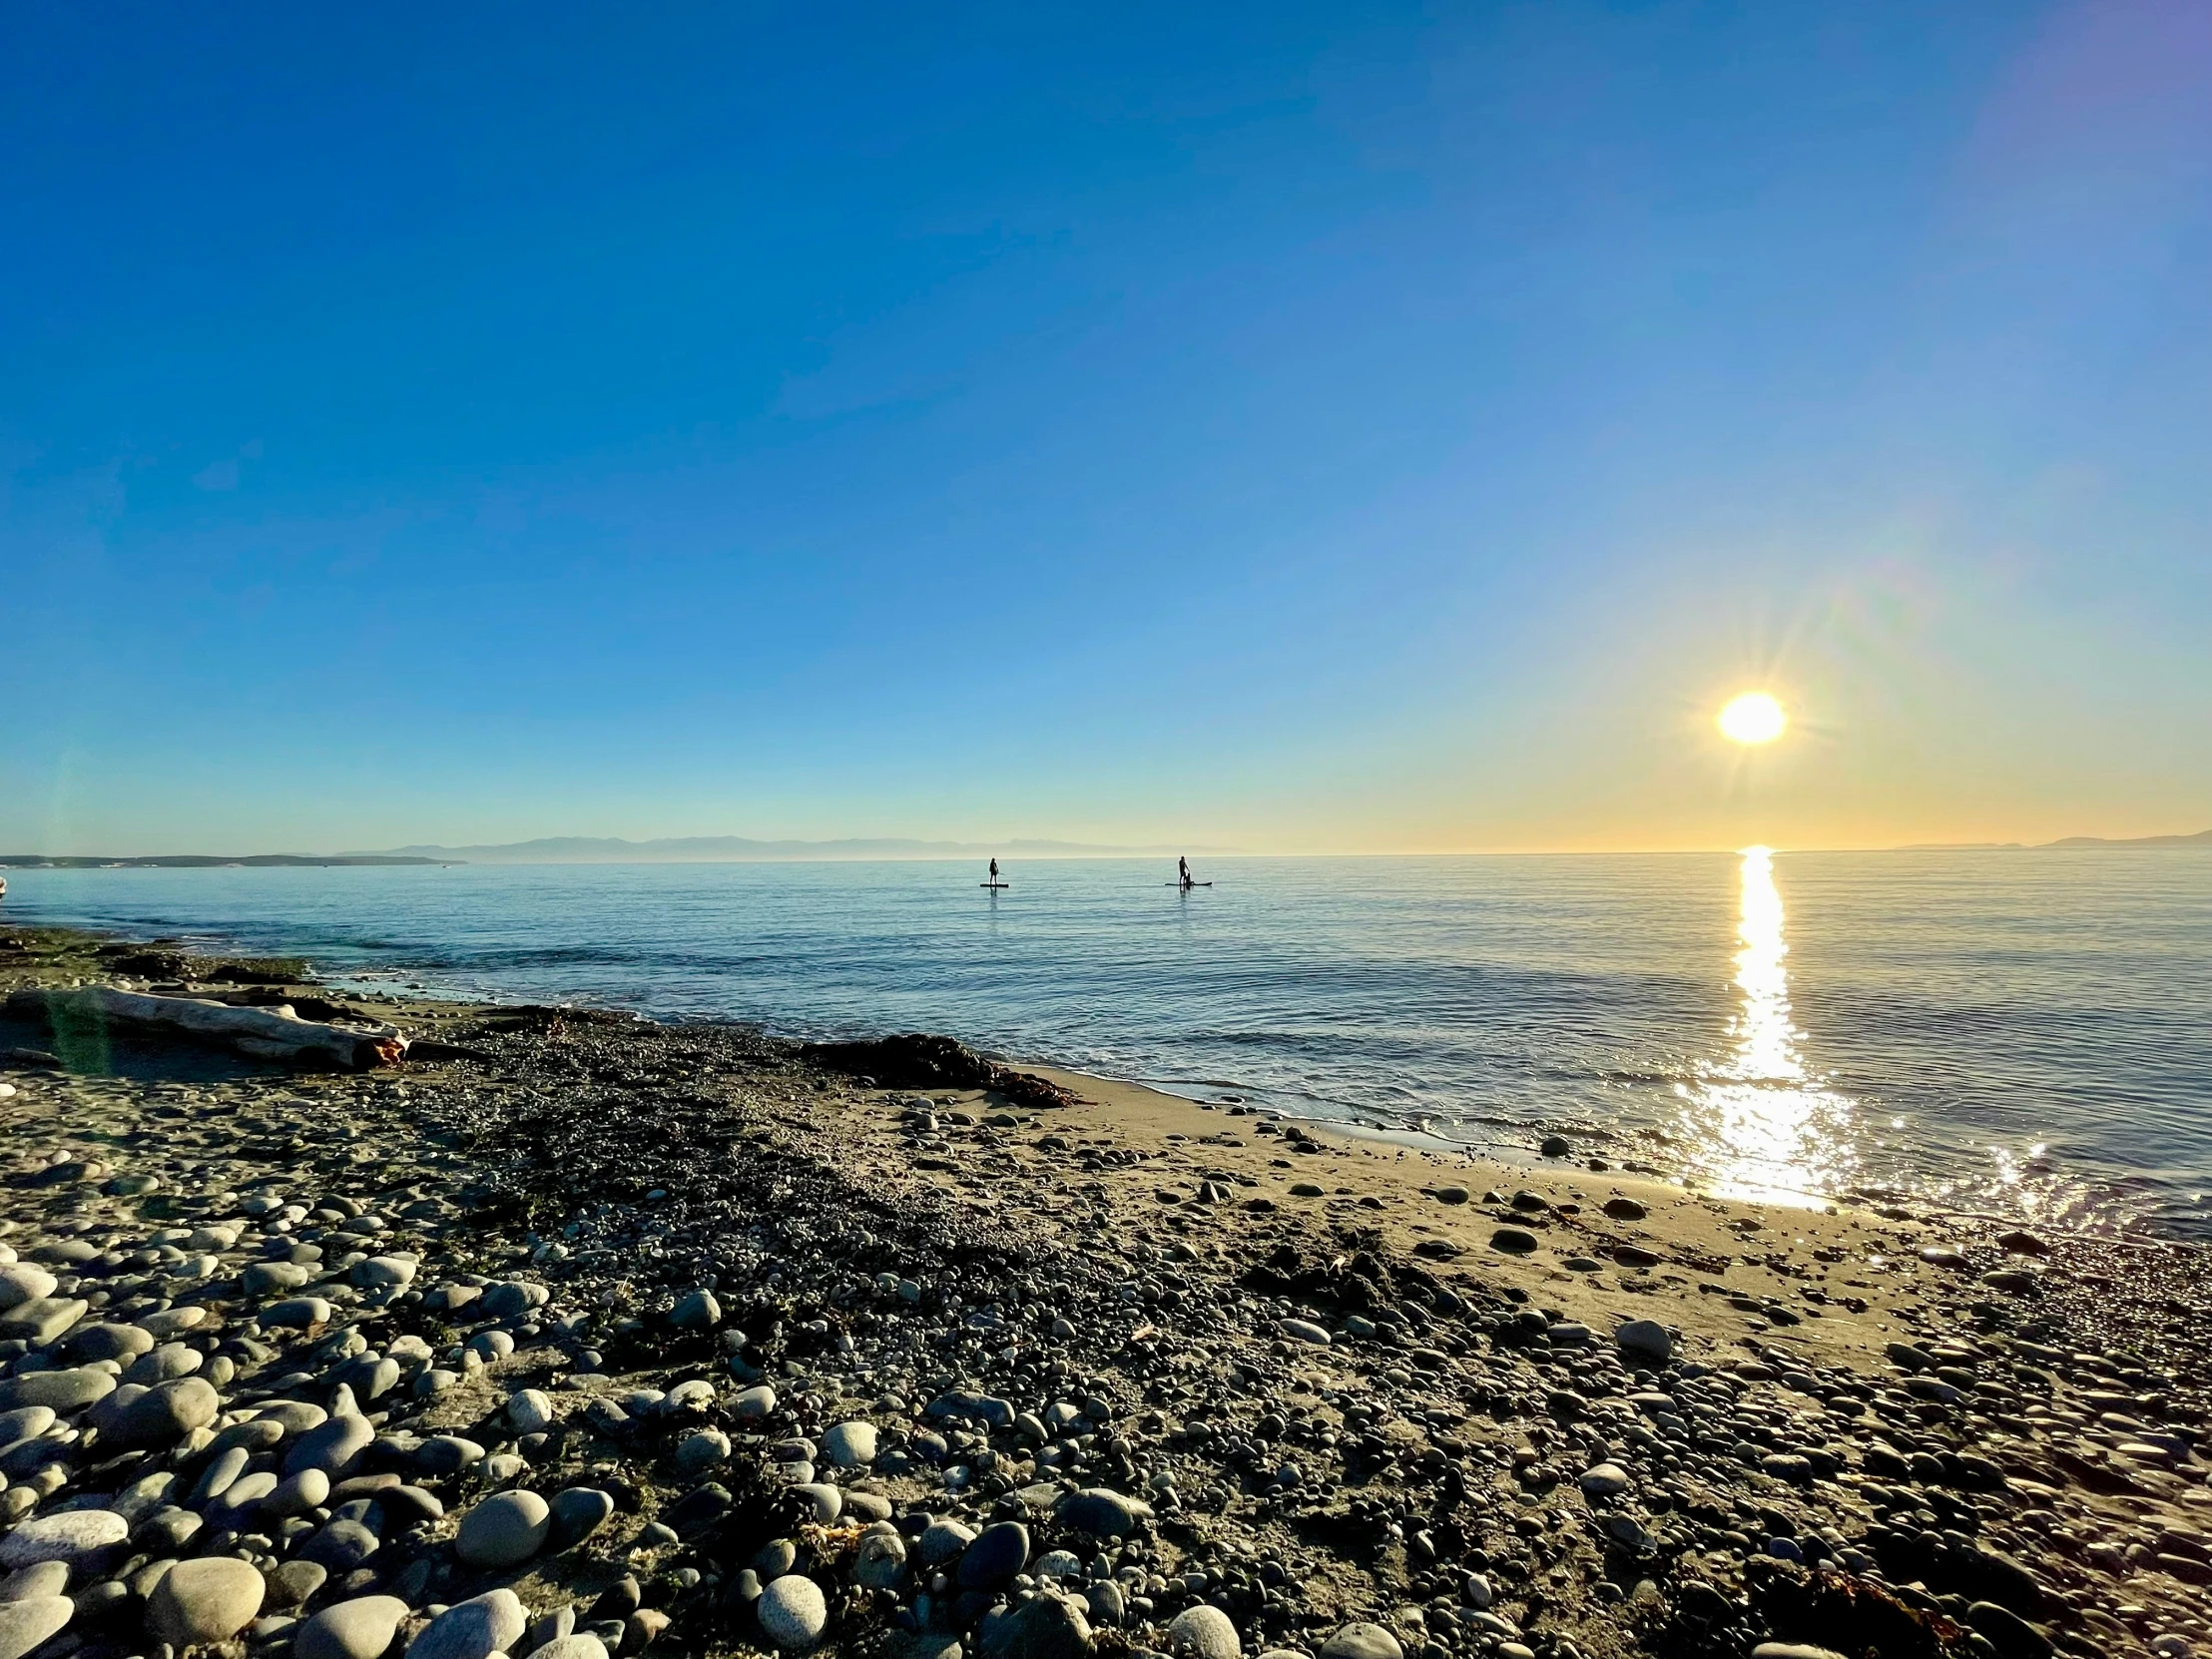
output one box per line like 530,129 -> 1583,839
0,849 -> 2212,1237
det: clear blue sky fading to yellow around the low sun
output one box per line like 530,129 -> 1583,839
0,0 -> 2212,851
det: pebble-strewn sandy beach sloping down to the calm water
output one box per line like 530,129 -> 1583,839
0,929 -> 2212,1659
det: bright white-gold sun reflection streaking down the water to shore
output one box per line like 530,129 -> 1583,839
1677,847 -> 1858,1206
